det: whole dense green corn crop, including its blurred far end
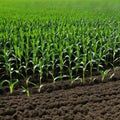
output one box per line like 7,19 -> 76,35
0,0 -> 120,96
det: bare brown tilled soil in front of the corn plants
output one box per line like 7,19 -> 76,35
0,69 -> 120,120
